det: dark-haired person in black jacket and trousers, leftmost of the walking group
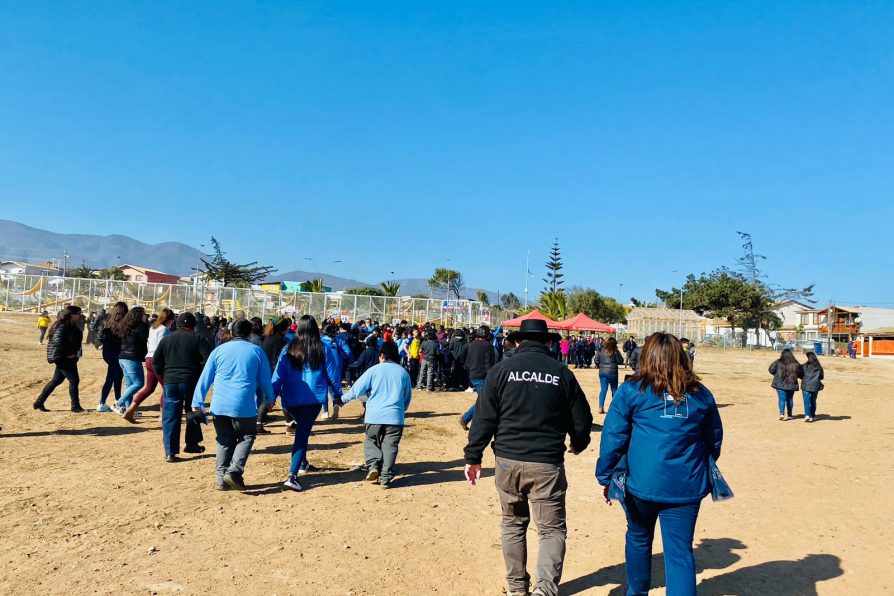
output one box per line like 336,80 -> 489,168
34,305 -> 84,412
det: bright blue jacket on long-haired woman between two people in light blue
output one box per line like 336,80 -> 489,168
273,343 -> 341,407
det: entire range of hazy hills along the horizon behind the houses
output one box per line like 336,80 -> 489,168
0,219 -> 497,301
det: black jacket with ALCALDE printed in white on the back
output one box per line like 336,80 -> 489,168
465,341 -> 593,464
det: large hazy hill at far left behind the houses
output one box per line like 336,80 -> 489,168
0,219 -> 202,275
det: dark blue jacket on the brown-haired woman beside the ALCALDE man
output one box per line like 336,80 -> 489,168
596,383 -> 723,503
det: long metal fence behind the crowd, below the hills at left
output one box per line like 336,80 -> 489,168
0,274 -> 495,326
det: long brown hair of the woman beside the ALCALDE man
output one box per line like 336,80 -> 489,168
630,333 -> 701,405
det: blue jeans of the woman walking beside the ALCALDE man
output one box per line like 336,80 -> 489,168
624,493 -> 700,596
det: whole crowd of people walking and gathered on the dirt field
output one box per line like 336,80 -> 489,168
28,302 -> 840,596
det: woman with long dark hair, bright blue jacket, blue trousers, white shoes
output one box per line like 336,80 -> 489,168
273,315 -> 341,490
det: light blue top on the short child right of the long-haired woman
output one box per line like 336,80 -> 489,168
342,362 -> 413,426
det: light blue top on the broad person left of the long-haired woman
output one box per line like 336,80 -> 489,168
192,339 -> 275,418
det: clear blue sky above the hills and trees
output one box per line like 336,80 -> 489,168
0,0 -> 894,306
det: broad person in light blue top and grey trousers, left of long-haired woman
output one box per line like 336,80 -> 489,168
192,319 -> 273,490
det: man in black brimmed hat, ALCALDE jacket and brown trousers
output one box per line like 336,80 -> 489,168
465,320 -> 593,596
